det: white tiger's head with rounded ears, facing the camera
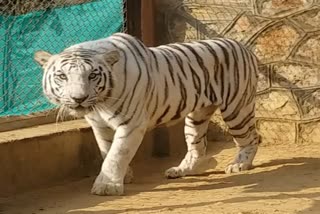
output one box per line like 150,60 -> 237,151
34,49 -> 120,117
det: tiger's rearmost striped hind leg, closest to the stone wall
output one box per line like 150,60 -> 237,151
222,101 -> 260,174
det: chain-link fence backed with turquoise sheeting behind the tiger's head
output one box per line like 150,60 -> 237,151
0,0 -> 126,117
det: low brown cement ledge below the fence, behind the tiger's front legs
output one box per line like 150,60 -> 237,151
0,120 -> 186,197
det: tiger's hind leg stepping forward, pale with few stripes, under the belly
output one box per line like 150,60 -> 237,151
165,106 -> 217,178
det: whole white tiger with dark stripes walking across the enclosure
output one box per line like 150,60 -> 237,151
35,33 -> 259,195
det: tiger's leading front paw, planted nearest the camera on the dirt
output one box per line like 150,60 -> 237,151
91,174 -> 124,196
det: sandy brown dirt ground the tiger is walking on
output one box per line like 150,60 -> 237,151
0,140 -> 320,214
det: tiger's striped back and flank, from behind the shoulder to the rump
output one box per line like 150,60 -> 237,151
147,39 -> 258,128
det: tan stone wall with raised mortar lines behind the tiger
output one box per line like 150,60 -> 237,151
157,0 -> 320,143
